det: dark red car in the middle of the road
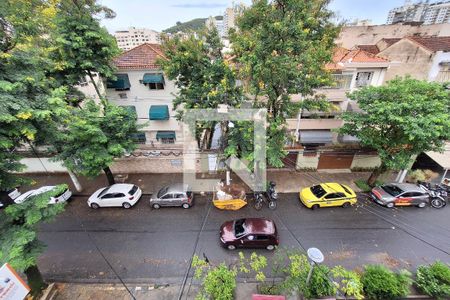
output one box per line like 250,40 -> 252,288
220,218 -> 278,250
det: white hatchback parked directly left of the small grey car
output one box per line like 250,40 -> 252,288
87,183 -> 142,209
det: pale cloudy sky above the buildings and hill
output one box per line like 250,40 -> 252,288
99,0 -> 405,33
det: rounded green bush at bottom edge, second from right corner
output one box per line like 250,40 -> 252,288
361,265 -> 412,300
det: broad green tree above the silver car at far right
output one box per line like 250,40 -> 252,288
339,78 -> 450,185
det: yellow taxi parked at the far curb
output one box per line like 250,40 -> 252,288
300,182 -> 357,209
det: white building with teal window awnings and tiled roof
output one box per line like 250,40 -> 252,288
106,44 -> 183,149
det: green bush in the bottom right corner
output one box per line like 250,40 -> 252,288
416,261 -> 450,299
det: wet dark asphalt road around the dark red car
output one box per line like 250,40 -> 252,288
39,194 -> 450,284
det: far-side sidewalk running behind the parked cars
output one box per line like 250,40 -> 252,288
22,170 -> 370,196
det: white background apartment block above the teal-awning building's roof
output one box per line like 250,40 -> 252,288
114,27 -> 161,51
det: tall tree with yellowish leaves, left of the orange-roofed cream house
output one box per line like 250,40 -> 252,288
230,0 -> 339,166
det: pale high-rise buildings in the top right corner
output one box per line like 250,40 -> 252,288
386,0 -> 450,25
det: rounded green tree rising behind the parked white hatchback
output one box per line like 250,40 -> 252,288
54,100 -> 139,185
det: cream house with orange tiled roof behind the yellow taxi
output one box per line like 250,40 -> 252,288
286,47 -> 391,170
